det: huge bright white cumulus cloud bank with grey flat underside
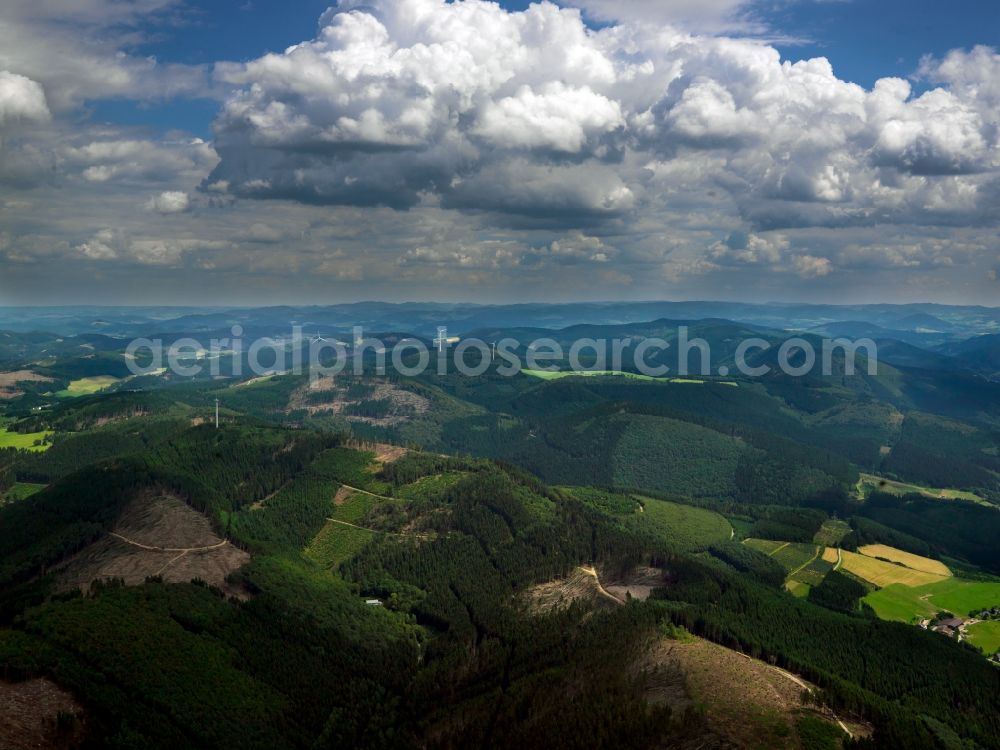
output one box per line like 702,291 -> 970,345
205,0 -> 1000,238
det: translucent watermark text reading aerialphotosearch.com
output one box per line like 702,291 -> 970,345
126,325 -> 878,379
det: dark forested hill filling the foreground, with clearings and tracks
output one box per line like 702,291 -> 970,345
0,422 -> 1000,748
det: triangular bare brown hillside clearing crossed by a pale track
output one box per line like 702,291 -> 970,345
59,491 -> 250,596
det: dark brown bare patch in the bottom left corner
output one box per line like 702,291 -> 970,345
0,678 -> 84,750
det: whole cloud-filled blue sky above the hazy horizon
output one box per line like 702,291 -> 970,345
0,0 -> 1000,304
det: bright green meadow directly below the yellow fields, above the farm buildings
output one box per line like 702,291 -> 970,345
864,578 -> 1000,622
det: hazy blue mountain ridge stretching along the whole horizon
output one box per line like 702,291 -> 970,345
0,301 -> 1000,343
